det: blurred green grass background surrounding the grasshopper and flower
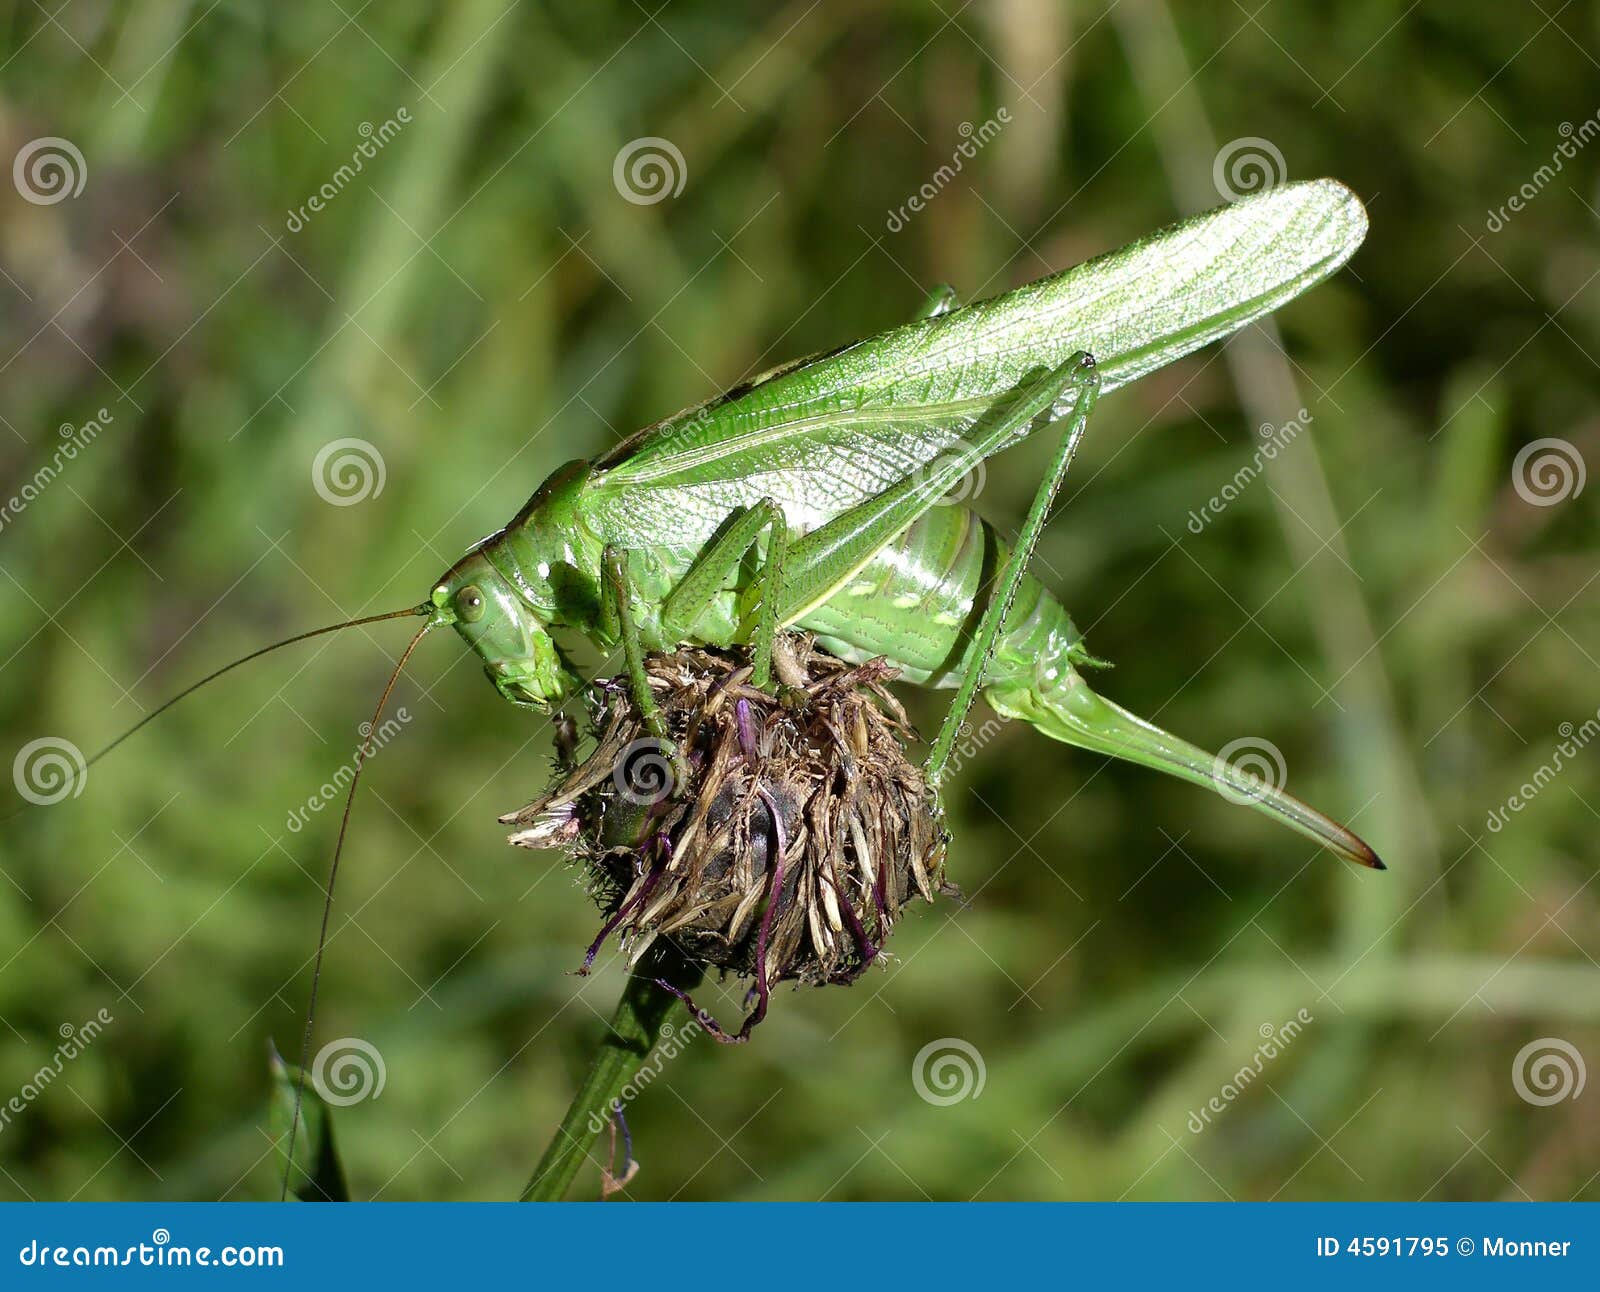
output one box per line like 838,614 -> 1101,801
0,0 -> 1600,1199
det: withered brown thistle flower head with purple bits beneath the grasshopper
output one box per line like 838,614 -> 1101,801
501,635 -> 946,1041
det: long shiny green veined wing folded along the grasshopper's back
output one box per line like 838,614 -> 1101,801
584,179 -> 1366,547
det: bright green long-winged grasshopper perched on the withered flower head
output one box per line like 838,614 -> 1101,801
419,179 -> 1382,868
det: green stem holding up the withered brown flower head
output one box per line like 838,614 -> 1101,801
522,939 -> 704,1202
